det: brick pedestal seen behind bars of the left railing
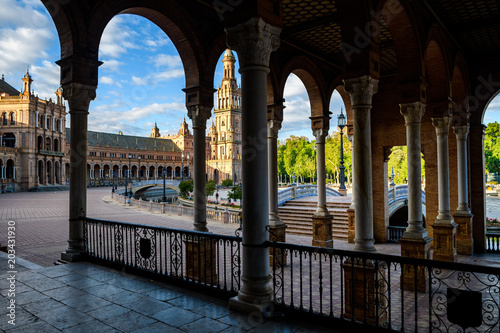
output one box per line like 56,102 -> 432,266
184,237 -> 218,285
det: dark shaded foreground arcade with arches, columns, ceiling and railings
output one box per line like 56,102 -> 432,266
13,0 -> 500,331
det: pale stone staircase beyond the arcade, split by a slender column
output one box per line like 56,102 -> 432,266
278,197 -> 351,240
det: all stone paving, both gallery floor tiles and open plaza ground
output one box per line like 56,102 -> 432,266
0,188 -> 500,332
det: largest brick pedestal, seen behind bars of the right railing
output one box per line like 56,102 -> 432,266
342,259 -> 387,325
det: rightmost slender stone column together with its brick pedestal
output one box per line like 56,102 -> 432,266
453,124 -> 473,255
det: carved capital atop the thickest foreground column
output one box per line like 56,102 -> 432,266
225,16 -> 281,70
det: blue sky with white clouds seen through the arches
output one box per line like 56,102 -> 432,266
0,0 -> 500,139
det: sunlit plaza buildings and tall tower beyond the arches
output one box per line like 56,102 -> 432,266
0,50 -> 241,192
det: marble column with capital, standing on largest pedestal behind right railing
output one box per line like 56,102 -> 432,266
344,75 -> 378,252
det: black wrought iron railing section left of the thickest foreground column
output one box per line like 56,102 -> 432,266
84,218 -> 241,295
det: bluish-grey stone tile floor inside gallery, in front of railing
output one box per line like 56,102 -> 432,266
0,252 -> 342,333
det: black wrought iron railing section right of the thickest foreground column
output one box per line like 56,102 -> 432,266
266,242 -> 500,332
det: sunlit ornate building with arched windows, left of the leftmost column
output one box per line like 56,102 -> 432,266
0,70 -> 69,192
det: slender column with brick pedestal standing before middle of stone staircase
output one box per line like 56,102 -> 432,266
312,126 -> 333,248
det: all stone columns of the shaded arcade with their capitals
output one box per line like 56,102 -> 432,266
63,17 -> 474,312
